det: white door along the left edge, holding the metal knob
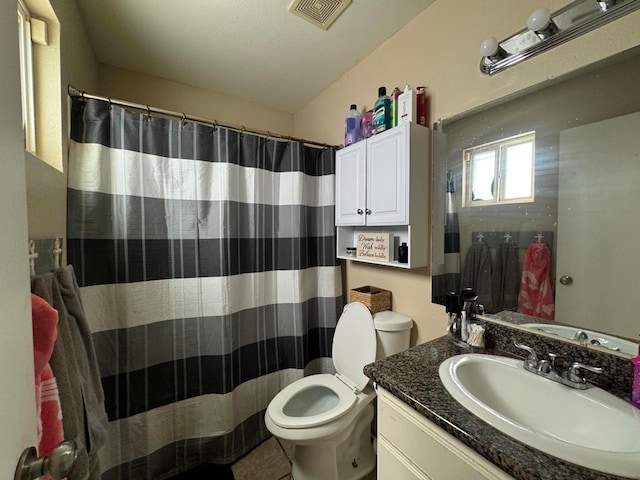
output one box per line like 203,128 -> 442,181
0,2 -> 36,468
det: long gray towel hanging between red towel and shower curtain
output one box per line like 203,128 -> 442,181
31,265 -> 108,480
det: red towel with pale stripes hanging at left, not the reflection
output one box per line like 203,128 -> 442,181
31,294 -> 64,456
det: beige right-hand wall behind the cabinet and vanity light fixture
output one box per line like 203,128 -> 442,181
294,0 -> 640,343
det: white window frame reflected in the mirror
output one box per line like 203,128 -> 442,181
462,130 -> 536,207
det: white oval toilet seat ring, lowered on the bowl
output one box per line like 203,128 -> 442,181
267,373 -> 358,428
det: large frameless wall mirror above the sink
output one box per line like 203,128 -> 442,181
432,47 -> 640,355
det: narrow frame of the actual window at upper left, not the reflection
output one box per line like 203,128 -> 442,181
17,0 -> 36,155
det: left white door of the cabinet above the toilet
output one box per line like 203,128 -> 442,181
335,142 -> 366,226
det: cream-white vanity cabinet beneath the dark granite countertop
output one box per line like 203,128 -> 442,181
377,388 -> 514,480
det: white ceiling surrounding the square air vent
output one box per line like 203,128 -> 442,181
77,0 -> 434,113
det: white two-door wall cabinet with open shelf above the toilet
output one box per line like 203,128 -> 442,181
335,124 -> 430,268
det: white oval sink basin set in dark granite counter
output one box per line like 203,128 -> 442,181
439,354 -> 640,479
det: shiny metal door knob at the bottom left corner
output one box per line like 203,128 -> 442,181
13,440 -> 78,480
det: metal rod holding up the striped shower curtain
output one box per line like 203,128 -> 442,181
68,85 -> 342,149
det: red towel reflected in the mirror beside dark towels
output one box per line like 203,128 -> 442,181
518,243 -> 555,320
